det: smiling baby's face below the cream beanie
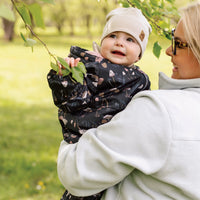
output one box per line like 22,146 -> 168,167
100,31 -> 141,66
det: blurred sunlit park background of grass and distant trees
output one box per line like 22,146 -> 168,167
0,0 -> 195,200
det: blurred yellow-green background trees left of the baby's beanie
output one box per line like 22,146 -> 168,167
0,0 -> 119,41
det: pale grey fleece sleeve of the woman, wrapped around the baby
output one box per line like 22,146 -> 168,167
57,92 -> 171,196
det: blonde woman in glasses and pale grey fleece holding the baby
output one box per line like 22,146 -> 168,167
58,3 -> 200,200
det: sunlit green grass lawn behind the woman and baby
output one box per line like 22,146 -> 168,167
0,30 -> 171,200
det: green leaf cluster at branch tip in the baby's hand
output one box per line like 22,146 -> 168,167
50,57 -> 86,84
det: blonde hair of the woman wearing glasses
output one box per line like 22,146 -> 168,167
181,1 -> 200,64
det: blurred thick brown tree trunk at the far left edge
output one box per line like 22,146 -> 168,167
2,18 -> 15,41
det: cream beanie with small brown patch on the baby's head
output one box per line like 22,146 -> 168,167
101,7 -> 152,58
